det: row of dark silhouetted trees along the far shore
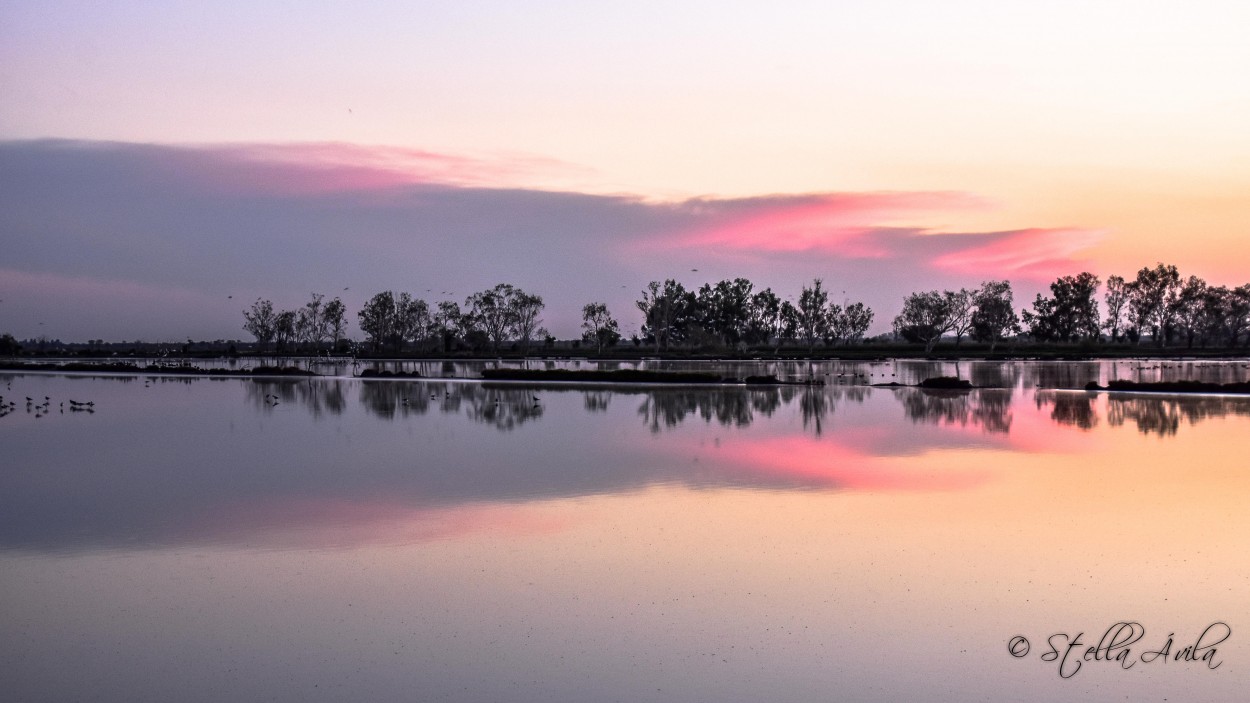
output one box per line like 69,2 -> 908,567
236,264 -> 1250,354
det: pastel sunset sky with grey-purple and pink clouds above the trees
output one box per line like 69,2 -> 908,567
0,0 -> 1250,341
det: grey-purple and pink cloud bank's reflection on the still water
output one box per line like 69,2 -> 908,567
7,374 -> 1250,552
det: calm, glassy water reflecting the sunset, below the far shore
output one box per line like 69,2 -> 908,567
0,362 -> 1250,702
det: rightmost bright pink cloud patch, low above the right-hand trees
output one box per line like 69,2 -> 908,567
933,228 -> 1104,280
